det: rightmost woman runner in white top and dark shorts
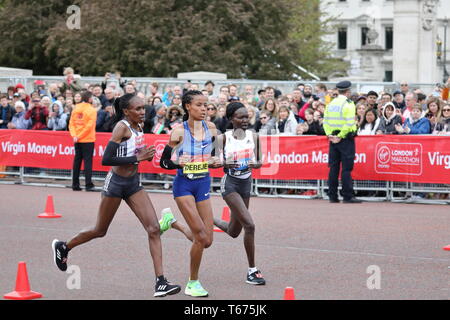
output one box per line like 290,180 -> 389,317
214,102 -> 266,285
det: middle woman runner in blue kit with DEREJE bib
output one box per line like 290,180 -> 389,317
160,90 -> 222,297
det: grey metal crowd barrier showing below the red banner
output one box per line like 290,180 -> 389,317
0,167 -> 450,204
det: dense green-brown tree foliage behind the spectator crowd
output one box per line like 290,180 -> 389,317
0,0 -> 344,80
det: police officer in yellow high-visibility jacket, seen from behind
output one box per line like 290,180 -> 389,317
323,81 -> 361,203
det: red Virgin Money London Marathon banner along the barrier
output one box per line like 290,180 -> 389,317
0,130 -> 450,183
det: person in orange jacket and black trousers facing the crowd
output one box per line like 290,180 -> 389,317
69,91 -> 97,191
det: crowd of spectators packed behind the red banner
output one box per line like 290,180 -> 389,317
0,68 -> 450,136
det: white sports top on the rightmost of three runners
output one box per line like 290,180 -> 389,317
224,130 -> 255,179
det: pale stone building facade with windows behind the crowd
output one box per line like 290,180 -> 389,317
321,0 -> 450,83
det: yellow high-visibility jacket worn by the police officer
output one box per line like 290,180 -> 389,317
323,95 -> 357,139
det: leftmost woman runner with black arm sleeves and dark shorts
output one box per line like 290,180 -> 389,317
52,94 -> 181,297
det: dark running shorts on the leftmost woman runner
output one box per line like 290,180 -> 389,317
102,170 -> 143,199
